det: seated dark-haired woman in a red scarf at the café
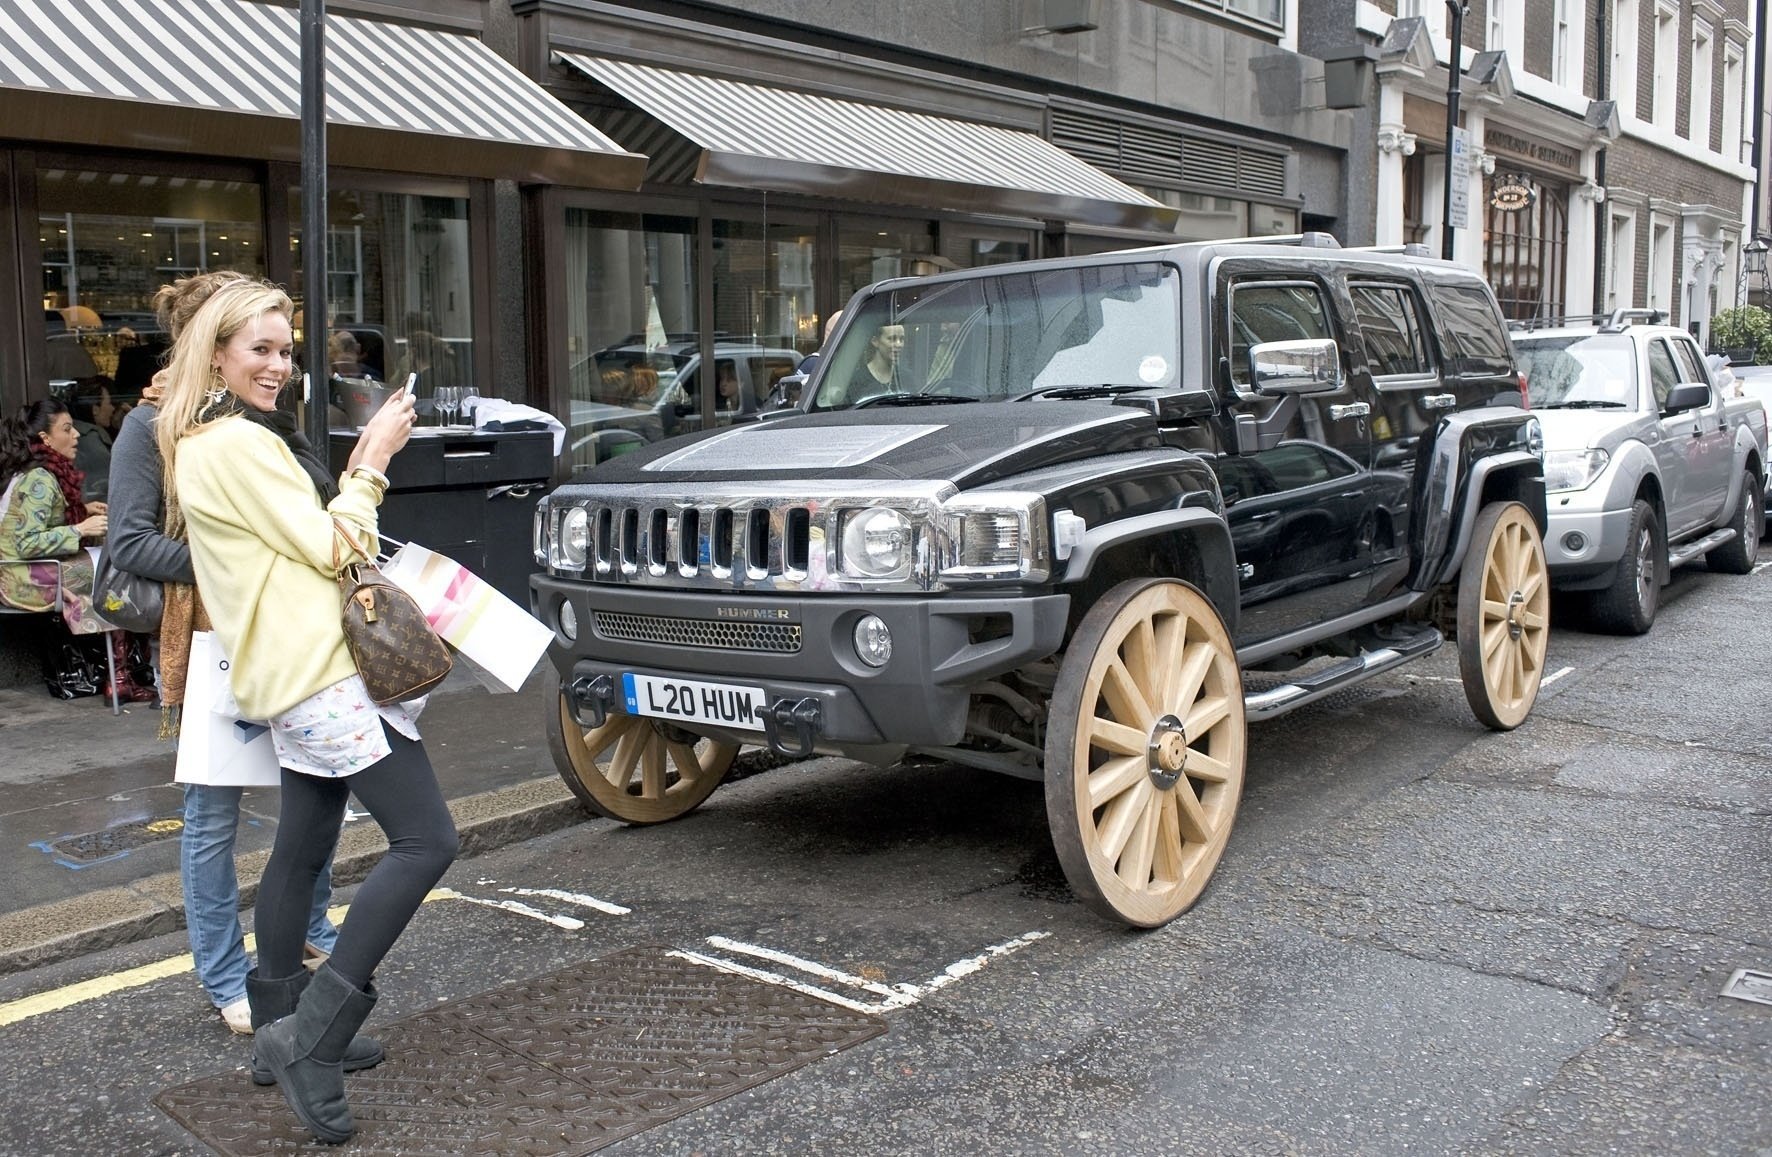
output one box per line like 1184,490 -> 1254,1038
0,399 -> 154,702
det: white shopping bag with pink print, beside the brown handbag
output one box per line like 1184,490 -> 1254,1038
381,542 -> 553,691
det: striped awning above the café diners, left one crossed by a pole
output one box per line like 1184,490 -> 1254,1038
0,0 -> 645,190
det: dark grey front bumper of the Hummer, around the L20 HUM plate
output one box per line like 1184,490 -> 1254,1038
530,574 -> 1070,755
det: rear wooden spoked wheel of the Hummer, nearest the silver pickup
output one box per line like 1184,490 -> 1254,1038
1458,501 -> 1551,732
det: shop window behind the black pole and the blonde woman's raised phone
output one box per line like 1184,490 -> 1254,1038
289,188 -> 482,427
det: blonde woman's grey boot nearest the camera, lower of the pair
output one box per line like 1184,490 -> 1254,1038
257,964 -> 376,1145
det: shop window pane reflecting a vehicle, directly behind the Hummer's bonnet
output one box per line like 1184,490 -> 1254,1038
562,207 -> 705,471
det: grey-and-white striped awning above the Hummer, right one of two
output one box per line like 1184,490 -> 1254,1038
555,53 -> 1177,232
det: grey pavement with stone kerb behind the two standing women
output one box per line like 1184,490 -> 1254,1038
0,666 -> 590,975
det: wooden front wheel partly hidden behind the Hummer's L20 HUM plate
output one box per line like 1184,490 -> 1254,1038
544,663 -> 739,824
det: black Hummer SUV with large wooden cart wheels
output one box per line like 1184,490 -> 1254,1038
533,234 -> 1549,927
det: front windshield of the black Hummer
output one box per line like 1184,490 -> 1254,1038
812,262 -> 1182,409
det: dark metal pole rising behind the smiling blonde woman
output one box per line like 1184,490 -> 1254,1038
301,0 -> 331,446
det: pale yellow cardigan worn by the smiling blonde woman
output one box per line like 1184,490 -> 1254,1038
174,416 -> 379,719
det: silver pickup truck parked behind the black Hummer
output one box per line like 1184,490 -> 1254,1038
1513,310 -> 1767,634
